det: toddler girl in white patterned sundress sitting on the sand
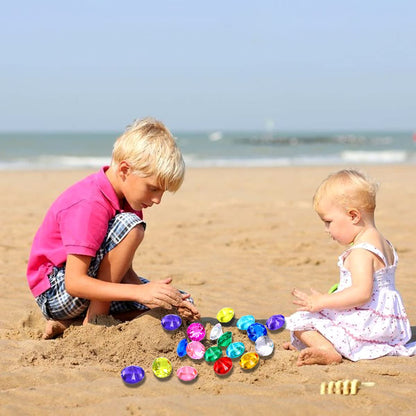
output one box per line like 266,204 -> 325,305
284,170 -> 416,365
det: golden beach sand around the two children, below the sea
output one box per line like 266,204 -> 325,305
0,166 -> 416,416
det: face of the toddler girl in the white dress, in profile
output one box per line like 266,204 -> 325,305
317,198 -> 358,246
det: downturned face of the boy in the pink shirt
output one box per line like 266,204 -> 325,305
121,171 -> 165,211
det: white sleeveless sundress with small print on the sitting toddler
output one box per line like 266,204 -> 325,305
286,243 -> 416,361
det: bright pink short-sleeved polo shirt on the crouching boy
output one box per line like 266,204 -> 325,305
27,167 -> 143,297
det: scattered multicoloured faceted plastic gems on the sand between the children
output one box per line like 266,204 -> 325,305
121,308 -> 285,385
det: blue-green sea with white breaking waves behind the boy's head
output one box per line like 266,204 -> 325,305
0,131 -> 416,170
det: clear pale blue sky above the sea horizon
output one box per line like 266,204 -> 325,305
0,0 -> 416,131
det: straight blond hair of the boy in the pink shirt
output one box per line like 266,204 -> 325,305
111,117 -> 185,192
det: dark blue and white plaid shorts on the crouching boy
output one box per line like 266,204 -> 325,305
36,212 -> 149,320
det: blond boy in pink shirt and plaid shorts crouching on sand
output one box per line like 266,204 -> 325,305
27,118 -> 200,339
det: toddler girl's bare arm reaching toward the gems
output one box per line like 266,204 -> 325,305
292,249 -> 375,312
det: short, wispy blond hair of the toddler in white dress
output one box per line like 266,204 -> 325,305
313,169 -> 378,213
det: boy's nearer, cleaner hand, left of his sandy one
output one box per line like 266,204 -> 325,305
137,278 -> 182,309
